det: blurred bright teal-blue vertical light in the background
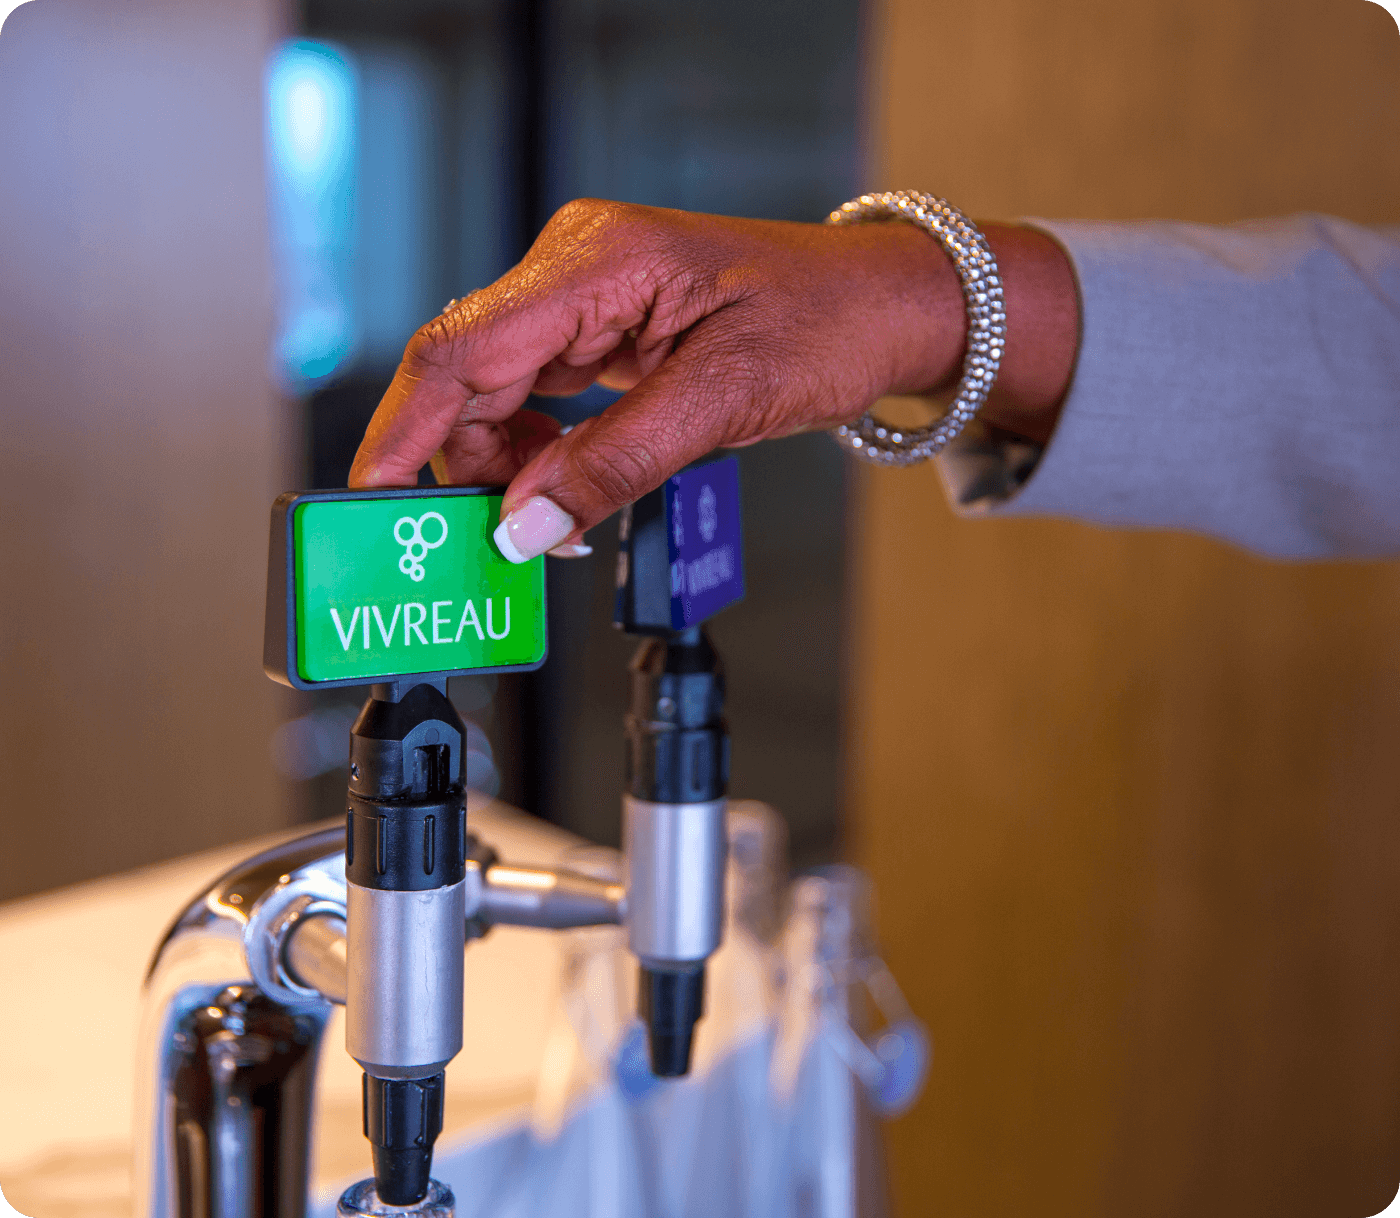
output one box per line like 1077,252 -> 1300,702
267,41 -> 357,389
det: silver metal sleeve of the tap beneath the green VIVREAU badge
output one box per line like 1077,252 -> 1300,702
346,882 -> 466,1078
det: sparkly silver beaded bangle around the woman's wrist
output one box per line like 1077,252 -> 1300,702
826,190 -> 1007,465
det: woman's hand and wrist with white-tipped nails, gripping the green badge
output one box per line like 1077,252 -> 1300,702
350,200 -> 1078,561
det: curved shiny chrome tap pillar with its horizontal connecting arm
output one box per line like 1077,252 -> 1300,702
133,822 -> 626,1218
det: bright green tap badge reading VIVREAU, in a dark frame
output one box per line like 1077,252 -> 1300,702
265,487 -> 546,687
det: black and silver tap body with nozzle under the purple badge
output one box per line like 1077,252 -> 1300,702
623,626 -> 729,1078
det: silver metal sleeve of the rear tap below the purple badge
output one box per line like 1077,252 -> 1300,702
623,795 -> 728,965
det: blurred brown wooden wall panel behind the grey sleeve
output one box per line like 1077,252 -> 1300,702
847,0 -> 1400,1218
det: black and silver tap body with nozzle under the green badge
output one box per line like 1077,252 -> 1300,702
346,680 -> 466,1205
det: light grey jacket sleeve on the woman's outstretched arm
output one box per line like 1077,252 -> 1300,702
941,216 -> 1400,559
